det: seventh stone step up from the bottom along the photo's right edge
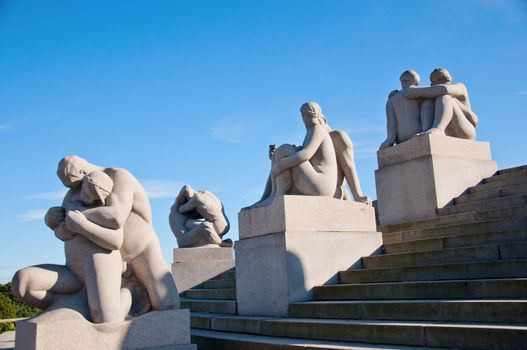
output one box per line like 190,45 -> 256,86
382,216 -> 527,244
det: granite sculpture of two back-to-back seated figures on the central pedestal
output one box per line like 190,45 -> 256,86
250,102 -> 369,209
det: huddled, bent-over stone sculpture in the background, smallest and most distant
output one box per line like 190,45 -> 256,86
169,185 -> 233,248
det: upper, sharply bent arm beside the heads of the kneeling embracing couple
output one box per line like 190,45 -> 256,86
83,169 -> 136,230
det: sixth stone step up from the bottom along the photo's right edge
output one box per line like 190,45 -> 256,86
384,228 -> 527,254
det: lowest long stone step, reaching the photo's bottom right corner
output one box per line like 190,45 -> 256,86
261,318 -> 527,350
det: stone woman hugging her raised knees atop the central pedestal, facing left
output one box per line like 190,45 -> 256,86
251,102 -> 338,207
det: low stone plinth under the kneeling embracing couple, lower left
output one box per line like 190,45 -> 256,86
15,309 -> 196,350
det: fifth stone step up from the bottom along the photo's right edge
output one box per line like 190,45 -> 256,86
362,243 -> 527,269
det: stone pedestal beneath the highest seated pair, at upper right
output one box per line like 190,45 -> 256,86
375,135 -> 497,225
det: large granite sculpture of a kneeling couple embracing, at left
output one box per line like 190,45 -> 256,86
12,156 -> 179,323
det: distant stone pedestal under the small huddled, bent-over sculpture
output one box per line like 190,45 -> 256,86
172,247 -> 234,293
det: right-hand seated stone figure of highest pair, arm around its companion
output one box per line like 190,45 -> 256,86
404,68 -> 478,140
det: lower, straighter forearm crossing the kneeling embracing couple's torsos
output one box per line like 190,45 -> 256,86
66,210 -> 124,250
